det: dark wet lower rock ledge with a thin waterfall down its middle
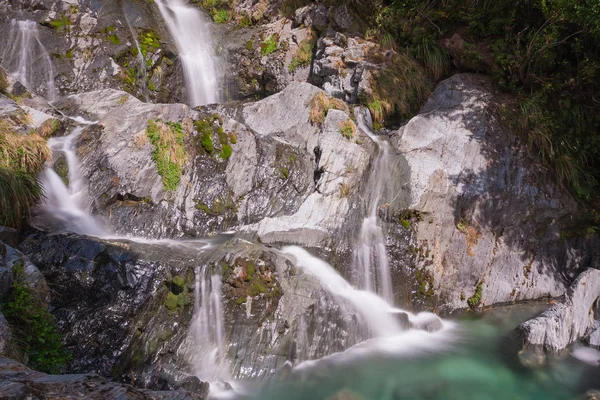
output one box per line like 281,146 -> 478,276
12,233 -> 354,384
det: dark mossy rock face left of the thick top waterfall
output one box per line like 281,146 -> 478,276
0,1 -> 184,102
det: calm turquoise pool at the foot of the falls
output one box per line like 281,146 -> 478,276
250,304 -> 600,400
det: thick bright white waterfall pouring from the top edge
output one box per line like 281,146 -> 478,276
156,0 -> 219,107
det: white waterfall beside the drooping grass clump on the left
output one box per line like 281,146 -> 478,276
40,118 -> 106,237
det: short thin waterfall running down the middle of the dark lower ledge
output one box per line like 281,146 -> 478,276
187,266 -> 230,383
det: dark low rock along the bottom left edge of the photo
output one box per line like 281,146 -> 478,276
0,357 -> 205,400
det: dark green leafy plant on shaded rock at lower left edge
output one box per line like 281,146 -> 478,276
2,264 -> 70,374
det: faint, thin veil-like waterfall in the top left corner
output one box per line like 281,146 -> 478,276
2,19 -> 56,101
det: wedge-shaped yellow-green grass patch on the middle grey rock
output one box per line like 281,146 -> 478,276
146,120 -> 187,191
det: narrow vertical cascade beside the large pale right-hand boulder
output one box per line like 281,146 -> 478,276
352,108 -> 393,302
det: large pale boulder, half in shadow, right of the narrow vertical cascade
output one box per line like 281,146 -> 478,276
393,74 -> 599,311
